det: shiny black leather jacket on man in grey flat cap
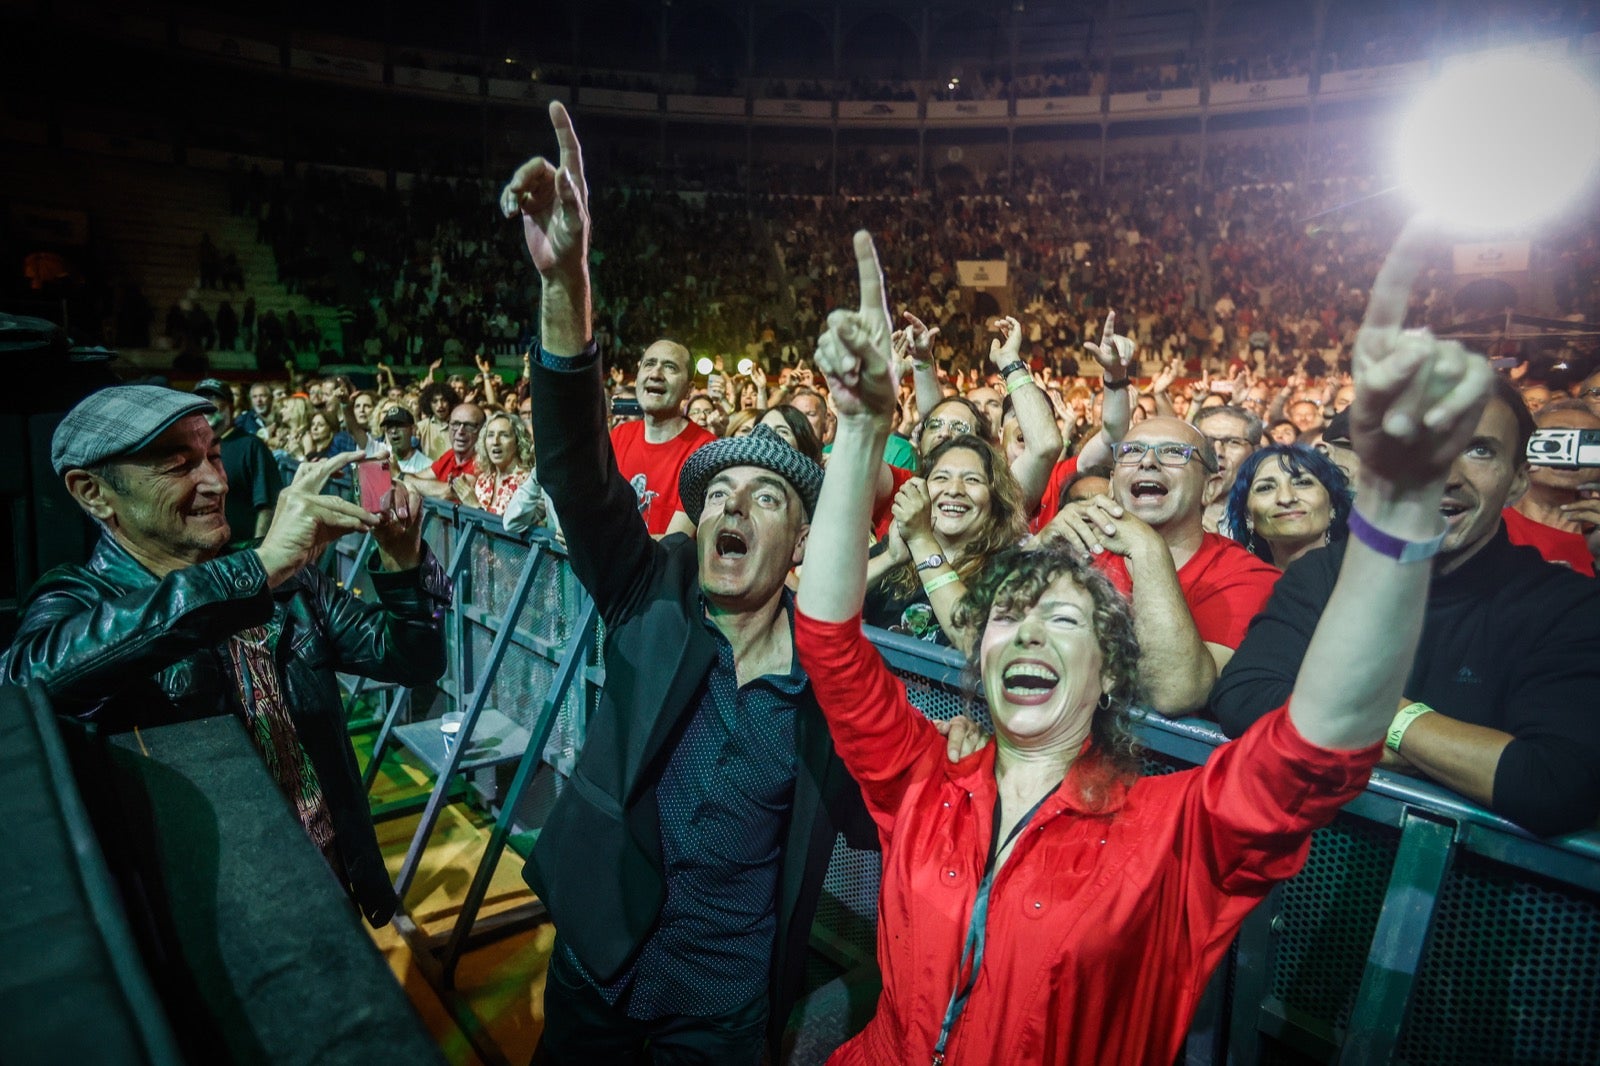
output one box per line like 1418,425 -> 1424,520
0,535 -> 451,925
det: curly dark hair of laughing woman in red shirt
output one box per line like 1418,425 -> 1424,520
955,543 -> 1142,810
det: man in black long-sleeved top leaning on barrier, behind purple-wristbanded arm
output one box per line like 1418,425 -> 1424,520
1211,379 -> 1600,836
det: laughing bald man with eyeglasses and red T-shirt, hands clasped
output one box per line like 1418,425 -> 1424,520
1042,418 -> 1278,717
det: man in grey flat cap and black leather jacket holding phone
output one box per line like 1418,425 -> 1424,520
0,386 -> 450,925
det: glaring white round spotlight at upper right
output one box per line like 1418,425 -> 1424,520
1397,56 -> 1600,230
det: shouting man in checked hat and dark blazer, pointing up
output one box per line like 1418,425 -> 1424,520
502,106 -> 972,1066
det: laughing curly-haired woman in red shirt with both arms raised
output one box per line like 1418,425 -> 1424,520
795,234 -> 1488,1066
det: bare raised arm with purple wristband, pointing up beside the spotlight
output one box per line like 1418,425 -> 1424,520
1290,222 -> 1491,749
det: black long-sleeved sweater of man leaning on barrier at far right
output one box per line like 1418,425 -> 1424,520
1211,525 -> 1600,836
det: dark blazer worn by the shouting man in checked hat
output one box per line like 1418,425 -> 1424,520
523,348 -> 877,1034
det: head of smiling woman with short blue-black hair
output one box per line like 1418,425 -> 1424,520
1227,445 -> 1352,570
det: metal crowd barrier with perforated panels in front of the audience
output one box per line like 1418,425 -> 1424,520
336,501 -> 1600,1066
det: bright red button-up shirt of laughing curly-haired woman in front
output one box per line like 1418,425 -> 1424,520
795,613 -> 1382,1066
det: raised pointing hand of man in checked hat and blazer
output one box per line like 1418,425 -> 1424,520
501,101 -> 589,277
